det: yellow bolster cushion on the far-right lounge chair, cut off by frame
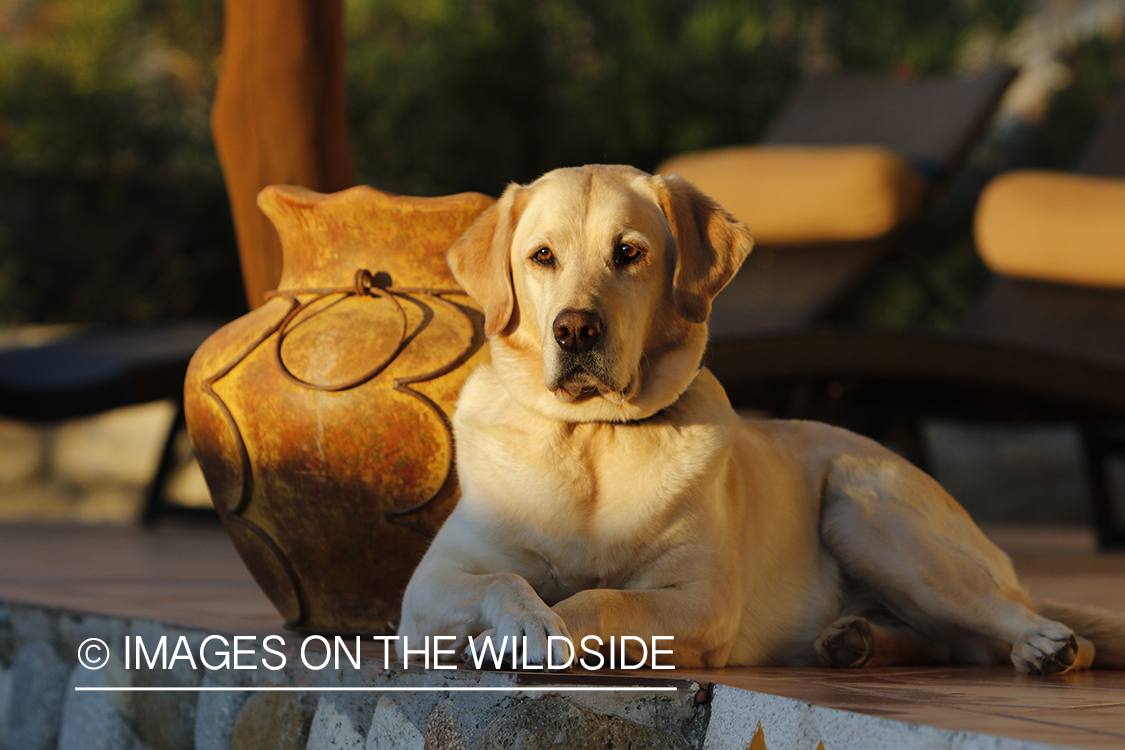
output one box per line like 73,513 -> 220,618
974,170 -> 1125,287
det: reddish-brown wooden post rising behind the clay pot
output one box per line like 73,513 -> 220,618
212,0 -> 356,309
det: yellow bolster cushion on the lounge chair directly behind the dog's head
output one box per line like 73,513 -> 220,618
657,146 -> 925,245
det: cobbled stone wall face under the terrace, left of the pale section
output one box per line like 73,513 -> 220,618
0,604 -> 710,750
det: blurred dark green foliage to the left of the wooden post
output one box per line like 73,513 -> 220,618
0,0 -> 243,322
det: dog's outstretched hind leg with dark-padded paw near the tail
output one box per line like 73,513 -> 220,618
821,451 -> 1087,674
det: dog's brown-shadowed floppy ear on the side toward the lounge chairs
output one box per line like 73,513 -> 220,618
653,174 -> 754,323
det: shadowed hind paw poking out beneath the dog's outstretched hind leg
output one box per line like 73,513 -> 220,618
815,616 -> 951,668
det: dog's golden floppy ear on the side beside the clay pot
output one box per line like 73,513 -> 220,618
446,182 -> 524,336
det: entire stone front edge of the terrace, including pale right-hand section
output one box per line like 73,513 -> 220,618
0,603 -> 1089,750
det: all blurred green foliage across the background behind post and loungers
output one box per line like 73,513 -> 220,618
0,0 -> 1122,325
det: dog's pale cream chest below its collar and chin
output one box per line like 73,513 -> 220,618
453,367 -> 738,597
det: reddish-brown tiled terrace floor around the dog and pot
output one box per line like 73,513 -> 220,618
0,525 -> 1125,750
